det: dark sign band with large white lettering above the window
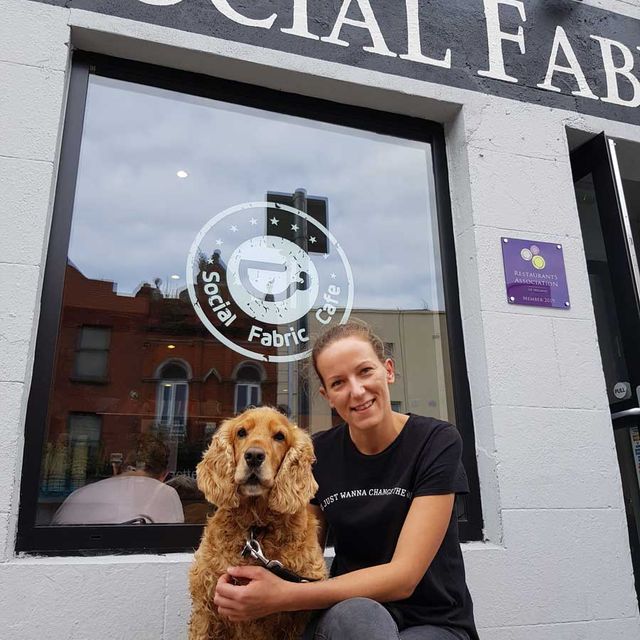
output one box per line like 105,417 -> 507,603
41,0 -> 640,124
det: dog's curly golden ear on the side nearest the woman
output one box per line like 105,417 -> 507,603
269,427 -> 318,513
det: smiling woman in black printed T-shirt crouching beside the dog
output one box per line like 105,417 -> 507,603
214,322 -> 478,640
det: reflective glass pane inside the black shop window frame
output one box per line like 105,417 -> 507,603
37,76 -> 453,524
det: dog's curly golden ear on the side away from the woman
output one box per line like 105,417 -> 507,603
196,420 -> 240,509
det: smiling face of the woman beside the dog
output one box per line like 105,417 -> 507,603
316,336 -> 395,429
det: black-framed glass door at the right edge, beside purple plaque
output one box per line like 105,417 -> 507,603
571,134 -> 640,595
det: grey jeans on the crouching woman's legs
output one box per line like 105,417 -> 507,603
302,598 -> 469,640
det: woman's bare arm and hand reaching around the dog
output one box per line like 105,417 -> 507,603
214,494 -> 455,621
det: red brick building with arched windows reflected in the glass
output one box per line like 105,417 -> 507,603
41,256 -> 277,495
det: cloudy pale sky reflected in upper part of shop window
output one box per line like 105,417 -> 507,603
69,76 -> 444,310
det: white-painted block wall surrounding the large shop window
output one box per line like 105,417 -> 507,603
0,0 -> 640,640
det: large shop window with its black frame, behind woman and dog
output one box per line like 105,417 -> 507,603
18,53 -> 482,553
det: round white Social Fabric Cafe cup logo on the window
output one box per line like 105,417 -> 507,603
186,202 -> 353,362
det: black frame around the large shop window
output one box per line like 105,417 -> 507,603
16,51 -> 482,555
